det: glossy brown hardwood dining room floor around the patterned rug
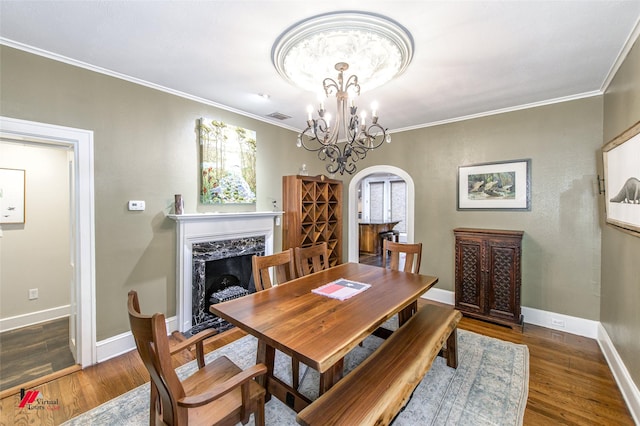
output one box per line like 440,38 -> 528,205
0,300 -> 634,426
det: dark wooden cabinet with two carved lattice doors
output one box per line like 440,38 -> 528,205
453,228 -> 524,326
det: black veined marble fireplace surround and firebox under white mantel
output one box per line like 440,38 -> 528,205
185,235 -> 265,335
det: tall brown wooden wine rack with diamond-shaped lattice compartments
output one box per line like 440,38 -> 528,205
282,175 -> 342,266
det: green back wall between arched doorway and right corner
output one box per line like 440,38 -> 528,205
342,96 -> 602,321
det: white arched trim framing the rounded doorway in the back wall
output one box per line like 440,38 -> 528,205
348,165 -> 415,262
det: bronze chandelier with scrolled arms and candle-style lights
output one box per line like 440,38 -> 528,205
296,62 -> 391,175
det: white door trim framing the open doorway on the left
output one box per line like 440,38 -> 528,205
0,116 -> 96,368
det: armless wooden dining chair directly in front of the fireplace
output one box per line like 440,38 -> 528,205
251,248 -> 300,389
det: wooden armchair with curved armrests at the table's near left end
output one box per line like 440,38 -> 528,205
127,290 -> 267,426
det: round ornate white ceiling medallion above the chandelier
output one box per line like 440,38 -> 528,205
271,12 -> 413,92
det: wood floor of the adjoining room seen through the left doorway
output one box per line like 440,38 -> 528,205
0,318 -> 75,391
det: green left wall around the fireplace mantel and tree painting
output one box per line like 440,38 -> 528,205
0,46 -> 310,341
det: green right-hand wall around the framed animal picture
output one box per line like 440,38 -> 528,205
598,40 -> 640,386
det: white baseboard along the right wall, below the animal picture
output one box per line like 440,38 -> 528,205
598,323 -> 640,424
